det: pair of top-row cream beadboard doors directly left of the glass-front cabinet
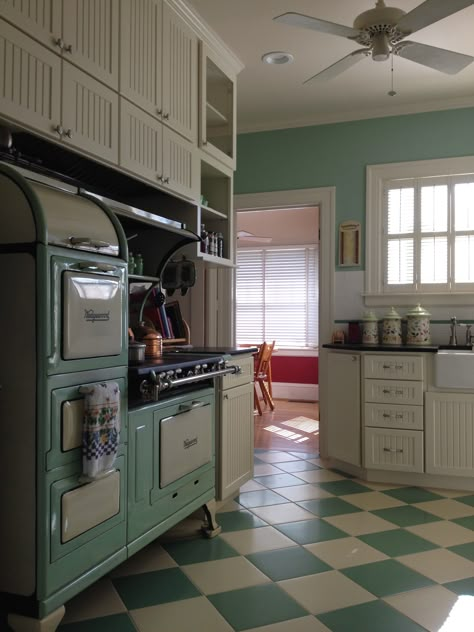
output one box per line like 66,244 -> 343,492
120,0 -> 198,142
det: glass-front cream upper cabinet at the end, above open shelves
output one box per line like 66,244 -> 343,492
200,43 -> 236,169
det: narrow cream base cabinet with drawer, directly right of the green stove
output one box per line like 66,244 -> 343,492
216,355 -> 254,500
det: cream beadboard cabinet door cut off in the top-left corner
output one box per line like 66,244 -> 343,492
0,0 -> 62,52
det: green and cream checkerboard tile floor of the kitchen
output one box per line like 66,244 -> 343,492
59,450 -> 474,632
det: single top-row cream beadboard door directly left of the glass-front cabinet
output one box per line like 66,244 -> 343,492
162,2 -> 198,142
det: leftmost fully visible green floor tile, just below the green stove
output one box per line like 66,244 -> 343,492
113,568 -> 201,608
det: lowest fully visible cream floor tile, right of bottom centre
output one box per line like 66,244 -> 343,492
277,571 -> 375,614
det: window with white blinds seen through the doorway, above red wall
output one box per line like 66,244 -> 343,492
236,245 -> 318,349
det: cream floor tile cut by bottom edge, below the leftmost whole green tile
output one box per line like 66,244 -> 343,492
130,597 -> 233,632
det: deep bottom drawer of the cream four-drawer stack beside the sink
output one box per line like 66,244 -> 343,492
364,428 -> 424,472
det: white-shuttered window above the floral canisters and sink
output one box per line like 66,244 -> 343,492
365,157 -> 474,305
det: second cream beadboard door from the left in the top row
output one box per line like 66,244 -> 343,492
63,0 -> 119,90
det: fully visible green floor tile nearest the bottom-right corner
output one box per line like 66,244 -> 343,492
341,560 -> 434,597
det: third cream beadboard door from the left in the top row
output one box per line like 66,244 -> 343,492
120,0 -> 163,119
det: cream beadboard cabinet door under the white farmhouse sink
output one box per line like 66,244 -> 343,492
425,392 -> 474,477
